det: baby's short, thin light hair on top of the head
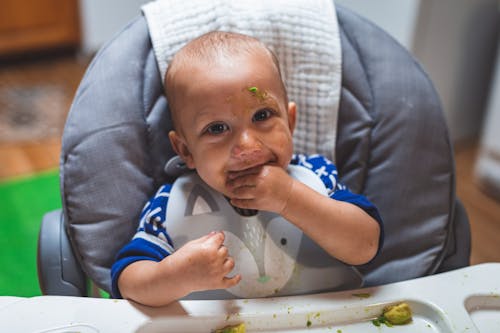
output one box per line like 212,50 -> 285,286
164,31 -> 288,121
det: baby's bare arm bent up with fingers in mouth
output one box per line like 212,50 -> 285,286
228,158 -> 381,265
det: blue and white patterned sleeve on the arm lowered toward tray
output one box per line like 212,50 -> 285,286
111,184 -> 174,298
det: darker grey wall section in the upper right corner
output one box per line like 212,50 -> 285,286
413,0 -> 498,142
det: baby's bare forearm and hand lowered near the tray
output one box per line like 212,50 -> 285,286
118,232 -> 241,306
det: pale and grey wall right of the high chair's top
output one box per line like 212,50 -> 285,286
336,0 -> 498,142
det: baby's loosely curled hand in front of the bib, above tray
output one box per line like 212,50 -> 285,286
167,232 -> 241,294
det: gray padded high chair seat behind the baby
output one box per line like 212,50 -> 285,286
38,6 -> 470,295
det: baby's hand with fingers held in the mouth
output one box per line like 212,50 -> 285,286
227,165 -> 294,214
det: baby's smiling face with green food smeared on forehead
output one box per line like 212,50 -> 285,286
170,52 -> 295,195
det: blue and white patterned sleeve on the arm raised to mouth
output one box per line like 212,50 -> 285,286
291,154 -> 384,251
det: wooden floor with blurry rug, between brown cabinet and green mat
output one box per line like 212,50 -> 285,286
0,51 -> 90,179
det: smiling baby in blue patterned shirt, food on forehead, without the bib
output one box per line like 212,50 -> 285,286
112,32 -> 383,306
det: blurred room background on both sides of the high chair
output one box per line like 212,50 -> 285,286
0,0 -> 500,296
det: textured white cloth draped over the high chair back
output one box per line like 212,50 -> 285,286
142,0 -> 342,161
